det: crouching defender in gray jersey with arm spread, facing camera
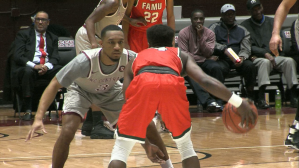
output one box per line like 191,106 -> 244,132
26,25 -> 173,168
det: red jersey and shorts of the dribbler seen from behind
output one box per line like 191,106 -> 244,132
116,47 -> 191,143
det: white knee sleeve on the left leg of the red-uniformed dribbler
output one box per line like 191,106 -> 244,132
110,139 -> 135,165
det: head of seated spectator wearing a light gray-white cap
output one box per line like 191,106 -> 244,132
220,4 -> 236,27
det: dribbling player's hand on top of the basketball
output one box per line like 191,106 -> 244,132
238,99 -> 257,127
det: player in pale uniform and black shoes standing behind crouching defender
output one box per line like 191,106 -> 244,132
75,0 -> 128,139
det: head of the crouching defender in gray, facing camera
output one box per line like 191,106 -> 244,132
100,25 -> 124,62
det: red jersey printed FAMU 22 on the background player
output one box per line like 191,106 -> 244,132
130,0 -> 166,31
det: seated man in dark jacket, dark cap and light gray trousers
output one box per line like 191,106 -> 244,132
241,0 -> 298,108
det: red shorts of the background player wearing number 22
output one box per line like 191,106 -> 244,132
128,27 -> 148,53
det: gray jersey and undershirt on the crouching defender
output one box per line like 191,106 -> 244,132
56,48 -> 136,93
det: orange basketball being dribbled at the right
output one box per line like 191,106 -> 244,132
222,103 -> 258,134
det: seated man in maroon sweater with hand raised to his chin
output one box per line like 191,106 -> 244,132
178,9 -> 224,112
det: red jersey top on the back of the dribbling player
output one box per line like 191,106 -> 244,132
132,47 -> 183,76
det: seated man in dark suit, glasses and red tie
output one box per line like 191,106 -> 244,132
12,11 -> 61,120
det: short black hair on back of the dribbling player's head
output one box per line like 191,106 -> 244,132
146,24 -> 174,47
